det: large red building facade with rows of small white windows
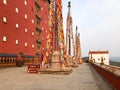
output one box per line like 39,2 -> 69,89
0,0 -> 49,65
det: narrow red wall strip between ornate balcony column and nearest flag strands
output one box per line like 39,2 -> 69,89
40,0 -> 50,55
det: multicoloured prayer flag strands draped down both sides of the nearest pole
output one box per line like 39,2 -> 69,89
43,0 -> 64,67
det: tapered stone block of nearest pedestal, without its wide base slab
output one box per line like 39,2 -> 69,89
50,51 -> 62,71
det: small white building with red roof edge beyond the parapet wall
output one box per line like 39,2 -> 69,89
89,51 -> 109,65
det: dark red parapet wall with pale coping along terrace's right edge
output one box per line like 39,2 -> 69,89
90,63 -> 120,90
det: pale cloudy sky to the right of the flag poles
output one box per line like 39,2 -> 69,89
62,0 -> 120,57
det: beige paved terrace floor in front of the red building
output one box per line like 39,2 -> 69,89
0,64 -> 112,90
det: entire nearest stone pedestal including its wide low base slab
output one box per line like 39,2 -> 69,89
39,51 -> 72,75
